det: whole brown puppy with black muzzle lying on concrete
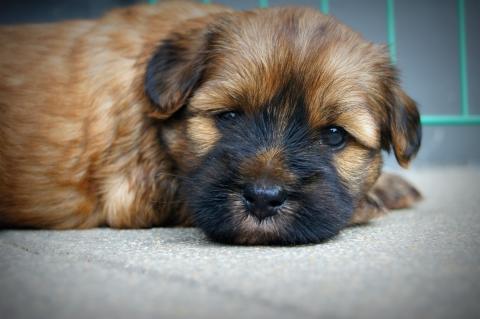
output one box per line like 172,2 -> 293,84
0,2 -> 421,244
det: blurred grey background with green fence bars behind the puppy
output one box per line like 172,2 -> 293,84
0,0 -> 480,168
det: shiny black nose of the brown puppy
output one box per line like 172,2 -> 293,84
243,184 -> 287,219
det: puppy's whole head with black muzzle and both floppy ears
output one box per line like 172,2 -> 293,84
146,9 -> 420,244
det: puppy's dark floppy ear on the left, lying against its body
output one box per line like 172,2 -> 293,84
145,19 -> 211,119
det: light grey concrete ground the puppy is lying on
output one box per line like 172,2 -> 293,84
0,168 -> 480,319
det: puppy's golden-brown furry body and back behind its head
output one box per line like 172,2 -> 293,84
0,2 -> 229,228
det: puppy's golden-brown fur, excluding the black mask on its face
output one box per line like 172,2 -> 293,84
0,3 -> 418,236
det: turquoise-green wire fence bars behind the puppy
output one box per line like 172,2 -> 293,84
149,0 -> 480,125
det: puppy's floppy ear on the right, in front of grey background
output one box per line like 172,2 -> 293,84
386,84 -> 422,167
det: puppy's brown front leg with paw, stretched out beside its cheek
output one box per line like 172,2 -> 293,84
350,173 -> 422,225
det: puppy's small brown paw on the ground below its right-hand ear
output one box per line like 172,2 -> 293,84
369,173 -> 422,209
